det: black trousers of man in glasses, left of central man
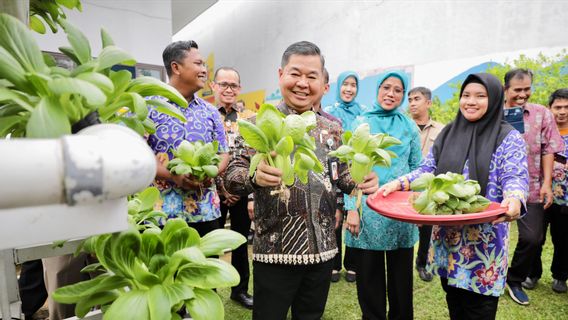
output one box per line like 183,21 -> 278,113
220,197 -> 250,295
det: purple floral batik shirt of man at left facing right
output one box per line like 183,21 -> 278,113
146,96 -> 228,223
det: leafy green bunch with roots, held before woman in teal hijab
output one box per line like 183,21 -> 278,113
329,123 -> 400,214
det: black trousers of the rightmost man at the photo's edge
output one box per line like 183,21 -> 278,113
529,204 -> 568,281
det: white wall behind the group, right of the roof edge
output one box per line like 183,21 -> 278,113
174,0 -> 568,102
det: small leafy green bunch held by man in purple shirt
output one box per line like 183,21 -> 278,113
167,140 -> 221,181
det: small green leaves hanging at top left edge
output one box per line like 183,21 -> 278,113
30,0 -> 83,34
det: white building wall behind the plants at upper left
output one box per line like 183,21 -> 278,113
32,0 -> 172,66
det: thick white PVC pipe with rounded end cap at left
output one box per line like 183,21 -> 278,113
0,124 -> 156,209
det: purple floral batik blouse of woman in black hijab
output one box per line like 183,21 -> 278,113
405,130 -> 529,297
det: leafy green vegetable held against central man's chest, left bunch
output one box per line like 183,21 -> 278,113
238,104 -> 323,186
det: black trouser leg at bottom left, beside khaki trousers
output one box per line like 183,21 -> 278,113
18,259 -> 47,319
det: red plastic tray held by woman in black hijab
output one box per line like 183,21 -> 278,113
367,191 -> 507,226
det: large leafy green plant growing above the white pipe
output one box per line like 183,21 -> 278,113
0,14 -> 187,138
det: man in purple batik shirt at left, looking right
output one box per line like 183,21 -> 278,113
148,40 -> 229,236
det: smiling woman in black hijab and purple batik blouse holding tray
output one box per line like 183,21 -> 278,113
377,73 -> 528,320
